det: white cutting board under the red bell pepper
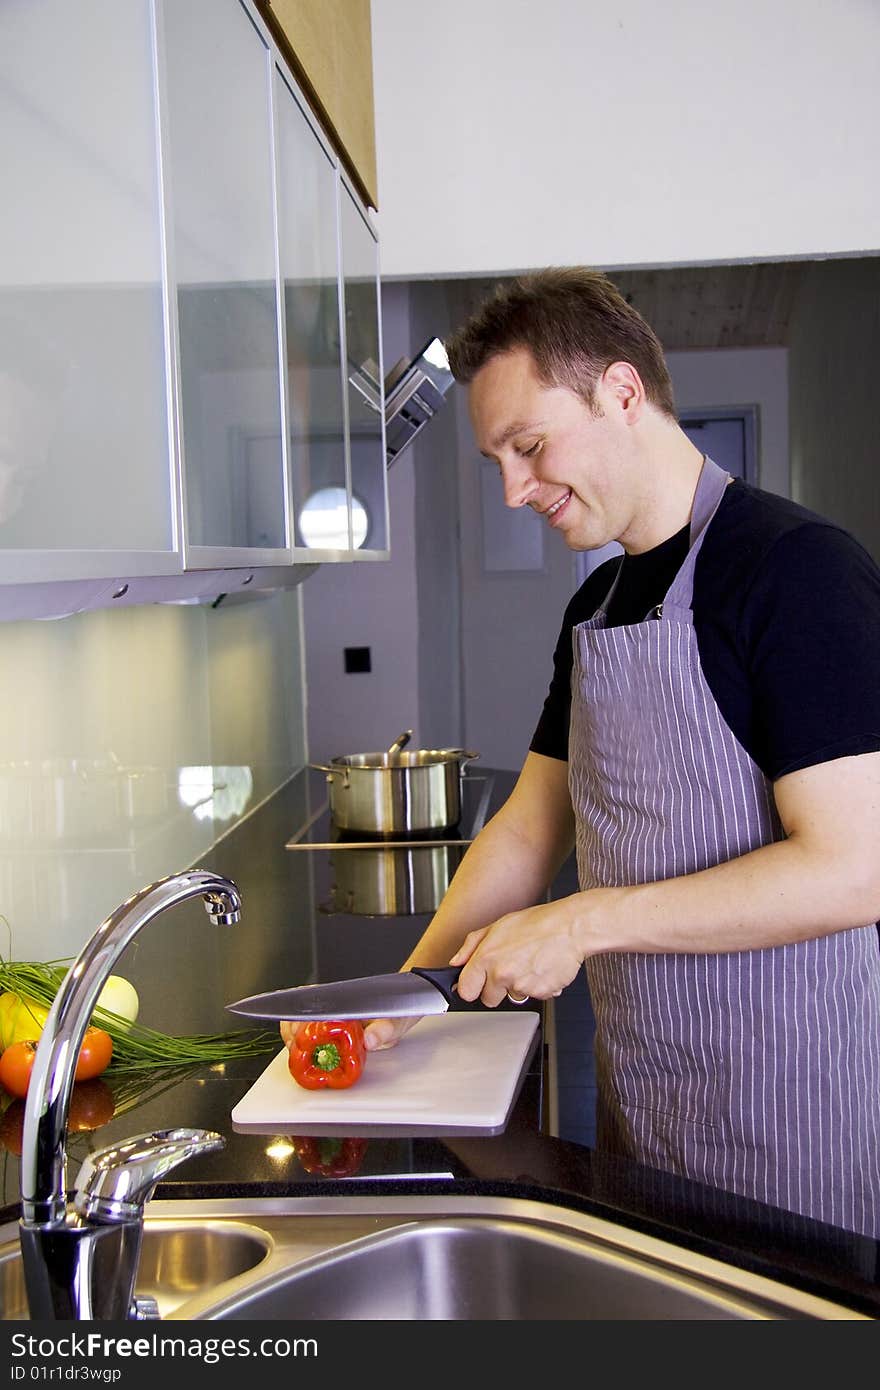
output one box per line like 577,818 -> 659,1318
232,1009 -> 538,1136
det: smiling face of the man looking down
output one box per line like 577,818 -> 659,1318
468,348 -> 638,550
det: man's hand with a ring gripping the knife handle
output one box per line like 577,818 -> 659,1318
449,898 -> 584,1008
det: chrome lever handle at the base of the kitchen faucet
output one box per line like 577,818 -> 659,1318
74,1129 -> 227,1222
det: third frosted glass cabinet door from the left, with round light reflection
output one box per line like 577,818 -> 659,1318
275,70 -> 350,560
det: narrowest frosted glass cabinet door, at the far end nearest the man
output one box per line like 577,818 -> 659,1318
339,179 -> 388,559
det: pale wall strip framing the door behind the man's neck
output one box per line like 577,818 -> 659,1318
666,348 -> 791,498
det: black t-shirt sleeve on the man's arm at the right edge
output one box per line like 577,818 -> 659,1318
740,523 -> 880,781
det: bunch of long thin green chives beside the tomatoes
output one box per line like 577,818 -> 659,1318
0,956 -> 279,1072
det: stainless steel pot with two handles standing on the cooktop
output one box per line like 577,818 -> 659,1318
310,748 -> 480,835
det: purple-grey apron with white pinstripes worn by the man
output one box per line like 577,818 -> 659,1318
569,459 -> 880,1237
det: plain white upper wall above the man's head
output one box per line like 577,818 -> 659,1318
373,0 -> 880,278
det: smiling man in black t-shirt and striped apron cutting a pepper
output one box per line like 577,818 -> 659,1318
284,270 -> 880,1236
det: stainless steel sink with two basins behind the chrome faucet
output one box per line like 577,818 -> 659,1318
0,1195 -> 870,1322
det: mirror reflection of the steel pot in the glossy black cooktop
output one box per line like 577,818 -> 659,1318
321,844 -> 467,917
